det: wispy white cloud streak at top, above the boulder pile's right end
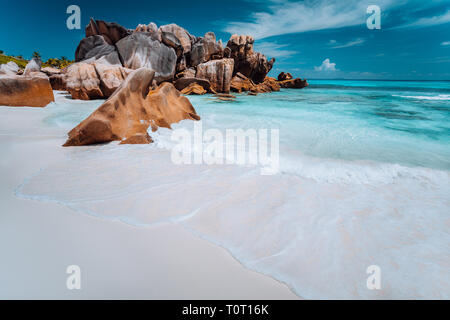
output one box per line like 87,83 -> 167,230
224,0 -> 394,39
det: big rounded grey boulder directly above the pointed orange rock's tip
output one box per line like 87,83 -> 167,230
116,32 -> 177,82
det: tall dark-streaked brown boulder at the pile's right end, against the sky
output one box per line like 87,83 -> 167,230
227,34 -> 275,83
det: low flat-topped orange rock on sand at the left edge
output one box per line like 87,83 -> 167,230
0,76 -> 55,107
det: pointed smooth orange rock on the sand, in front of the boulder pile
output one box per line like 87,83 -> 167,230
64,68 -> 200,146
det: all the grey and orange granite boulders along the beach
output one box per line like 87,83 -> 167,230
0,19 -> 308,146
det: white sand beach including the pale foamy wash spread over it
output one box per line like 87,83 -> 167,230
0,92 -> 450,299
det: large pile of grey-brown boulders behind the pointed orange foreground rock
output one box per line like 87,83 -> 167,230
50,19 -> 307,100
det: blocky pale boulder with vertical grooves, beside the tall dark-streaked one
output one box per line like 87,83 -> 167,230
196,58 -> 234,93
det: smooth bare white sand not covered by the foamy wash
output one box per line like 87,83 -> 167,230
0,94 -> 298,299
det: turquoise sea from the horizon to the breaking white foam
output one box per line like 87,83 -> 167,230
190,80 -> 450,175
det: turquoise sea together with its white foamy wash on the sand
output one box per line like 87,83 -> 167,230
16,81 -> 450,299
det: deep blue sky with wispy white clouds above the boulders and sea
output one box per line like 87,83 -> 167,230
0,0 -> 450,80
